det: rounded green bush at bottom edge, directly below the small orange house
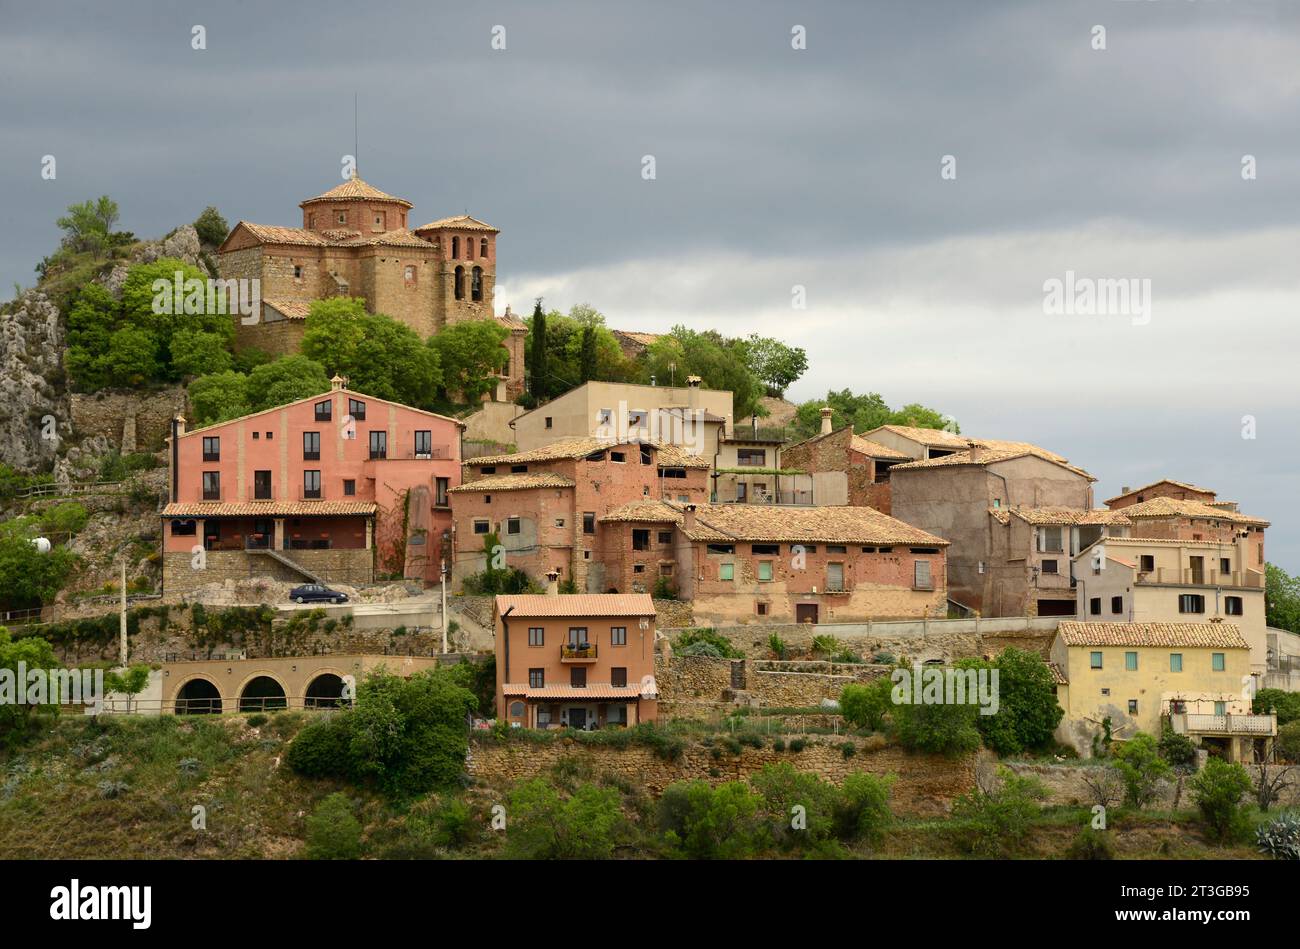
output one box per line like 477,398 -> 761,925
506,777 -> 628,861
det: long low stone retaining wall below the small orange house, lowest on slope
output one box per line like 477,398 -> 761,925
469,736 -> 975,816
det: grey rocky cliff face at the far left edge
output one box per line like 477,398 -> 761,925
0,284 -> 70,475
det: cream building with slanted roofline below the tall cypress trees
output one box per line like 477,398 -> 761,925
510,376 -> 732,464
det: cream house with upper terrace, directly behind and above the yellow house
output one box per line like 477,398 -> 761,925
1074,537 -> 1268,676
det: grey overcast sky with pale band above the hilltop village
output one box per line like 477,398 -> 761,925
0,0 -> 1300,572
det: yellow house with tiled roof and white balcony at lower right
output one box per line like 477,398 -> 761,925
1052,620 -> 1277,762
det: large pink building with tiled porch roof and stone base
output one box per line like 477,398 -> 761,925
163,377 -> 464,594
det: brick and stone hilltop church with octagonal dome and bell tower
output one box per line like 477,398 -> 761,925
217,174 -> 527,400
